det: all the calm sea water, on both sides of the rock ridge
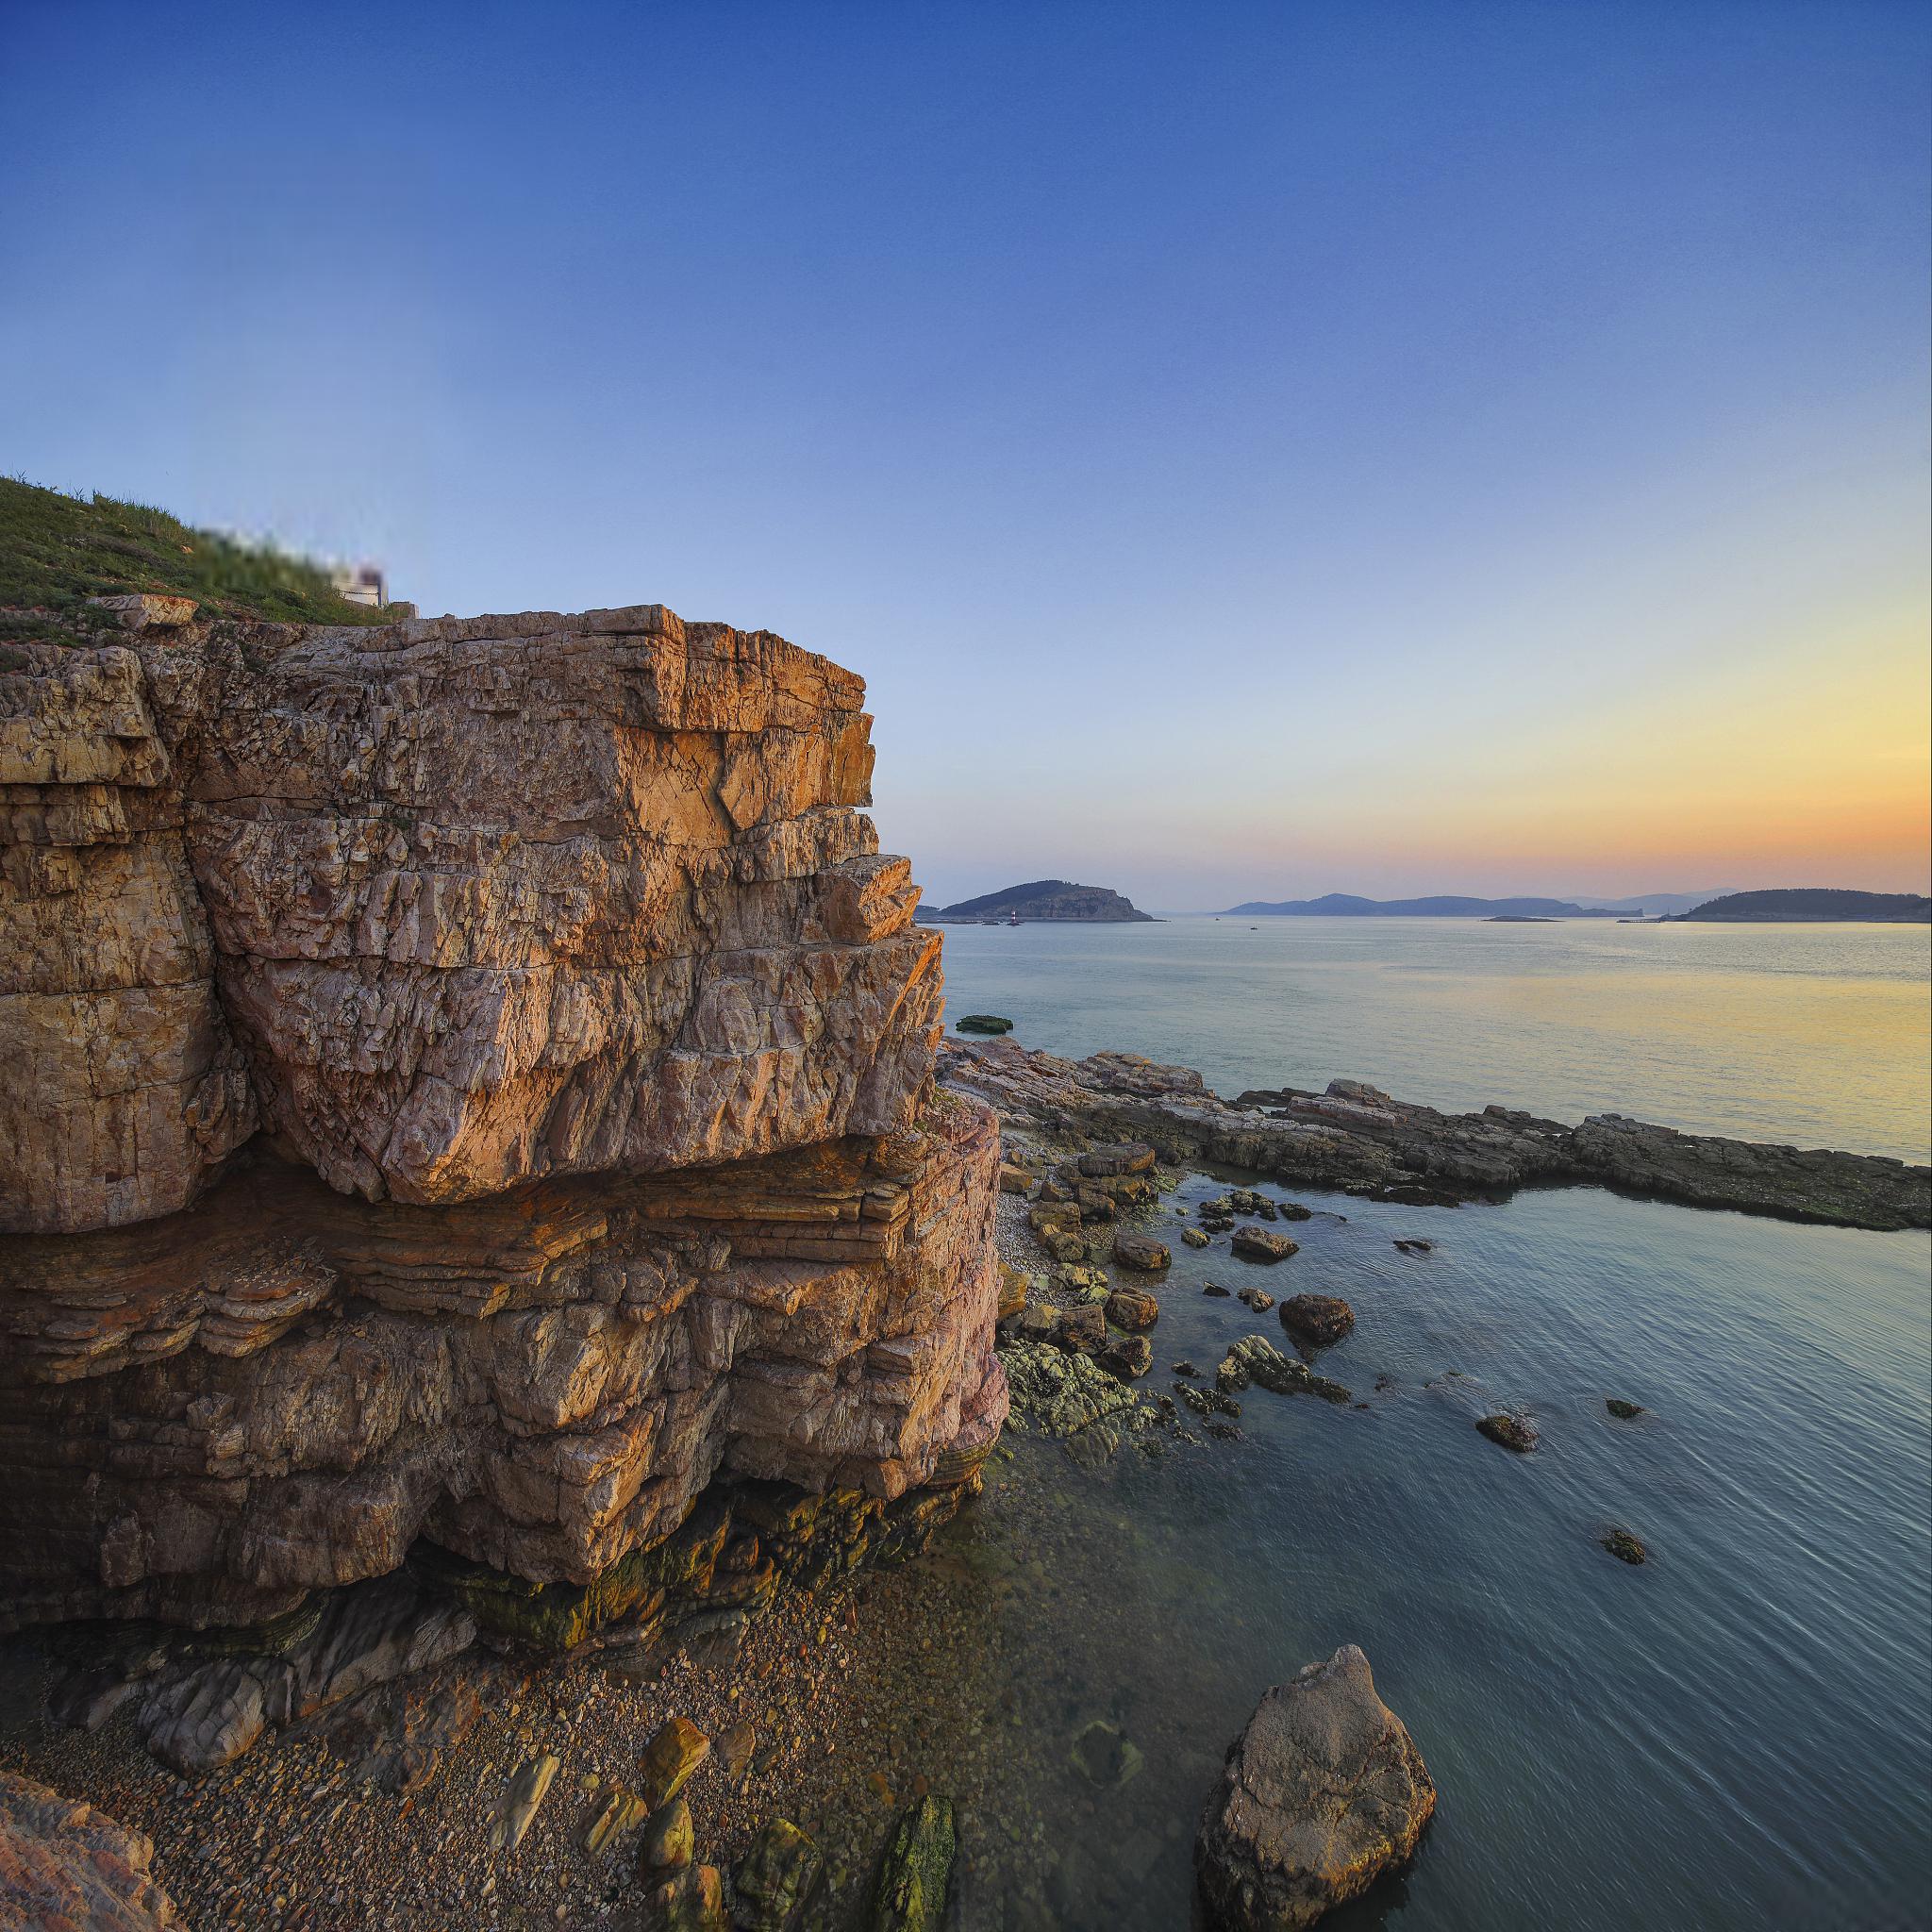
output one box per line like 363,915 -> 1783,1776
933,920 -> 1932,1932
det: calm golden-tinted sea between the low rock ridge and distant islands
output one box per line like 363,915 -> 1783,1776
927,918 -> 1932,1161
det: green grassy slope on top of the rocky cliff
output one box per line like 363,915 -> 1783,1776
0,477 -> 402,643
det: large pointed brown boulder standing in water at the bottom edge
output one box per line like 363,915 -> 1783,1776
1194,1644 -> 1436,1932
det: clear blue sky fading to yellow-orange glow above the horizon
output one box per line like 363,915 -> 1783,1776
0,0 -> 1932,910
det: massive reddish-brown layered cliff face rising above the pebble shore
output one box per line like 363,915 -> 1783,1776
0,607 -> 1005,1623
